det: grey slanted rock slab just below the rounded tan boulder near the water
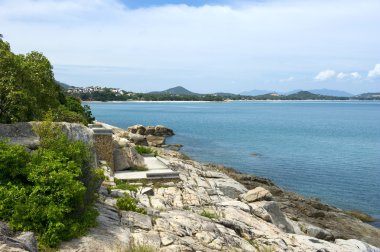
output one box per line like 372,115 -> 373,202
258,201 -> 294,233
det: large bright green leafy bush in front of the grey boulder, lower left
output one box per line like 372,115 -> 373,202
0,122 -> 104,247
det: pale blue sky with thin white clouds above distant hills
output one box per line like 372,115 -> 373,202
0,0 -> 380,94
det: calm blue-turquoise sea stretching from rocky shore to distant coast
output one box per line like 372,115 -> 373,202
85,102 -> 380,226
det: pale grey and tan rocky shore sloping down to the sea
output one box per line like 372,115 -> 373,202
0,121 -> 380,252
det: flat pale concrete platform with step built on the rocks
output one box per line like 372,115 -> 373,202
114,157 -> 179,180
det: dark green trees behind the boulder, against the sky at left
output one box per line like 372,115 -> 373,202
0,38 -> 94,124
